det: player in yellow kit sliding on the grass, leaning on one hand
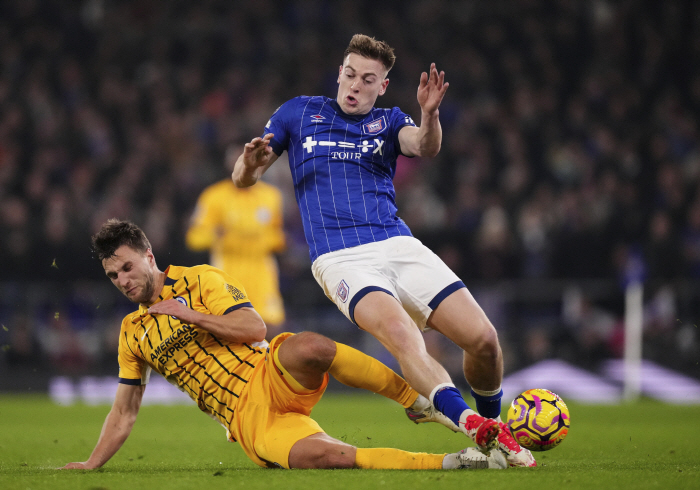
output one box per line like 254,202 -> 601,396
58,219 -> 507,469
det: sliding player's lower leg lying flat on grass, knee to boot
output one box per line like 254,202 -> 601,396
289,433 -> 507,470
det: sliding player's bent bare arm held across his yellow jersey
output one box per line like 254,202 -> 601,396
148,299 -> 267,343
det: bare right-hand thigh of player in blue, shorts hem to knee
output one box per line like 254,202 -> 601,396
428,288 -> 498,354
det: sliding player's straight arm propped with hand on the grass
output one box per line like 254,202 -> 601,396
61,384 -> 146,470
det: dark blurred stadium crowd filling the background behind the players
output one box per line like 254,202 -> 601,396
0,0 -> 700,386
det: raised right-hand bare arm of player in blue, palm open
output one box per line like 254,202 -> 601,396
399,63 -> 450,157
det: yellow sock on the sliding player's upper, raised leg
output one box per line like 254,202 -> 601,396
328,342 -> 418,408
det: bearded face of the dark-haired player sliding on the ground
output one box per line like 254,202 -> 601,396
102,245 -> 156,304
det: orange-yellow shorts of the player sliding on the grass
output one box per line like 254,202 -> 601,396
229,332 -> 328,468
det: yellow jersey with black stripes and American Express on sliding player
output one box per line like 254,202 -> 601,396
119,265 -> 265,427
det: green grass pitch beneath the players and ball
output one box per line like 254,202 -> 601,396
0,392 -> 700,490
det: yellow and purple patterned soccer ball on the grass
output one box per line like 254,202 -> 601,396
506,389 -> 570,451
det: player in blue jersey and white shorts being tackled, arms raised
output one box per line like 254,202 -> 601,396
232,34 -> 536,466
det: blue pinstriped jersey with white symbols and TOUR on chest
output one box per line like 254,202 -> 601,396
263,96 -> 415,261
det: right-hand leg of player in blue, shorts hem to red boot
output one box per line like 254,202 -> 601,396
428,288 -> 537,466
